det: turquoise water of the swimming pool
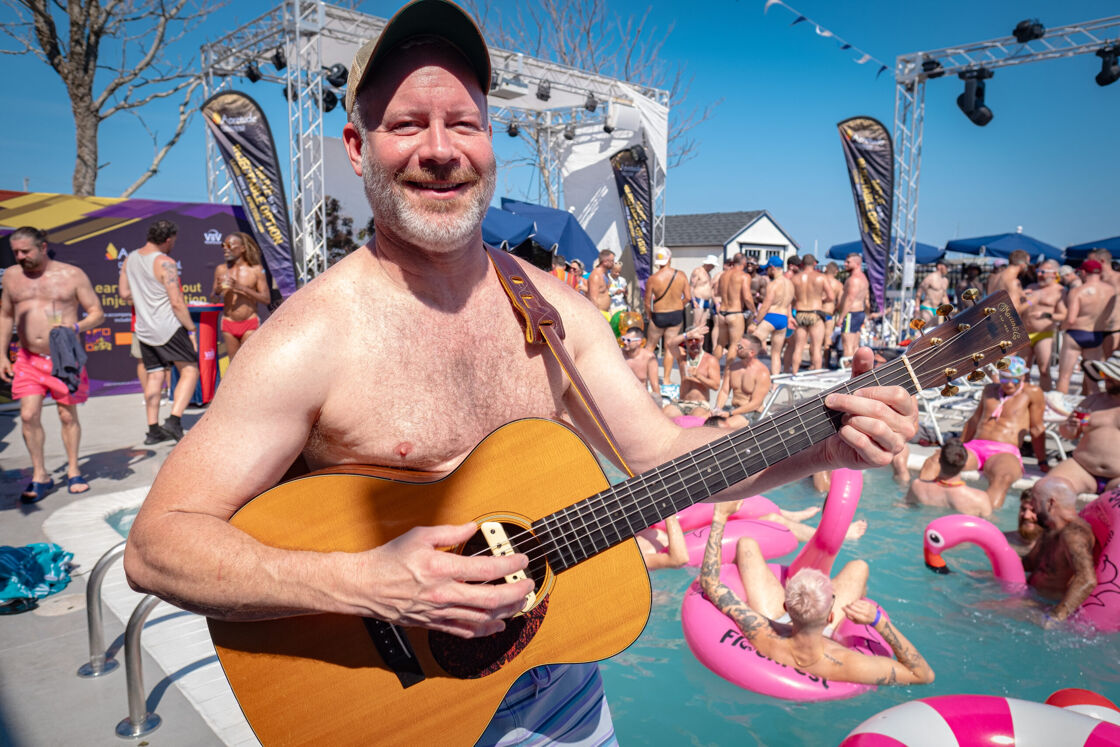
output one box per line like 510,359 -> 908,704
601,469 -> 1120,745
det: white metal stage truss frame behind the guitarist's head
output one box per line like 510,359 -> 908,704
200,0 -> 669,284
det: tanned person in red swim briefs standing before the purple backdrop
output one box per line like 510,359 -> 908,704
211,233 -> 269,362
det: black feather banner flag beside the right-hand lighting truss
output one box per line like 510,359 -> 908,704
837,116 -> 895,310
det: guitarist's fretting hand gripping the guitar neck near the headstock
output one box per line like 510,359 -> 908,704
821,347 -> 917,469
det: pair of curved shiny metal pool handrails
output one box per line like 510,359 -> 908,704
77,540 -> 162,739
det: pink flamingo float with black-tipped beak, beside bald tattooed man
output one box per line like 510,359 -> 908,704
924,488 -> 1120,633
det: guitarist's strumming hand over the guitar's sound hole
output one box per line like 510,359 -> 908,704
354,522 -> 533,638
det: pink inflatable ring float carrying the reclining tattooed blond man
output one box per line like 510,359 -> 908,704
681,469 -> 892,701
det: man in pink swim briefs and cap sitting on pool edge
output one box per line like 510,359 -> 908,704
918,355 -> 1046,511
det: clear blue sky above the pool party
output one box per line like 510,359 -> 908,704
0,0 -> 1120,251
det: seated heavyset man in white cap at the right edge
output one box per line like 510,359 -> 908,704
1049,356 -> 1120,493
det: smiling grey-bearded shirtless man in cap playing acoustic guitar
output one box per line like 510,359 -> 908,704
118,7 -> 917,744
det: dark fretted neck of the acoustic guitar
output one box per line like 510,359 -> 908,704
533,357 -> 920,572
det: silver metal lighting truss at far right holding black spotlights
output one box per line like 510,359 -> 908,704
892,16 -> 1120,338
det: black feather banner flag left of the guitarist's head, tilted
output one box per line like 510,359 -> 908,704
202,91 -> 296,298
